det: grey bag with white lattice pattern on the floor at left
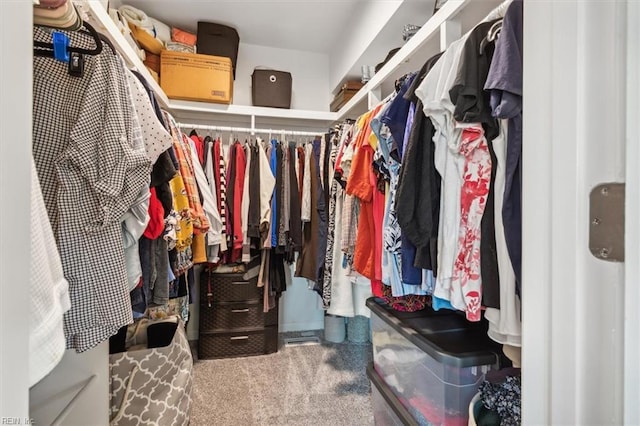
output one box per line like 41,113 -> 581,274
109,320 -> 193,426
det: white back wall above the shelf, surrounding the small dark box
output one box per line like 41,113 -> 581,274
233,42 -> 331,111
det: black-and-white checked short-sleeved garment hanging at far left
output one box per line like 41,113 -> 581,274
33,27 -> 151,352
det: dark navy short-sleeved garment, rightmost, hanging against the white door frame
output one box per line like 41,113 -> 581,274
484,0 -> 523,294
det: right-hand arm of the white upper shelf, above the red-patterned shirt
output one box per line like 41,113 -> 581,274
337,0 -> 502,120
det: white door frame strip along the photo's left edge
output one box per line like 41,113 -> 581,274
0,0 -> 33,424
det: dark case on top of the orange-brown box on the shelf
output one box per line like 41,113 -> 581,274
196,21 -> 240,80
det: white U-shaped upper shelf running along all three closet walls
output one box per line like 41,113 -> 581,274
76,0 -> 503,127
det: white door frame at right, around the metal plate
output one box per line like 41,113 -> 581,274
523,0 -> 640,425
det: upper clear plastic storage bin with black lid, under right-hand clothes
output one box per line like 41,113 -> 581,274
367,298 -> 501,426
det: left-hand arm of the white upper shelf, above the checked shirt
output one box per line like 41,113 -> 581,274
77,0 -> 169,108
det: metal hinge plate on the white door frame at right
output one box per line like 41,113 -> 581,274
589,182 -> 625,262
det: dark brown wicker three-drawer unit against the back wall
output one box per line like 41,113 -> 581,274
198,270 -> 278,359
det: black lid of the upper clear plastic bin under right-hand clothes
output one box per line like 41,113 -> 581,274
367,297 -> 502,368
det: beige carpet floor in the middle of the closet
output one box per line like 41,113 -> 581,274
191,335 -> 373,426
